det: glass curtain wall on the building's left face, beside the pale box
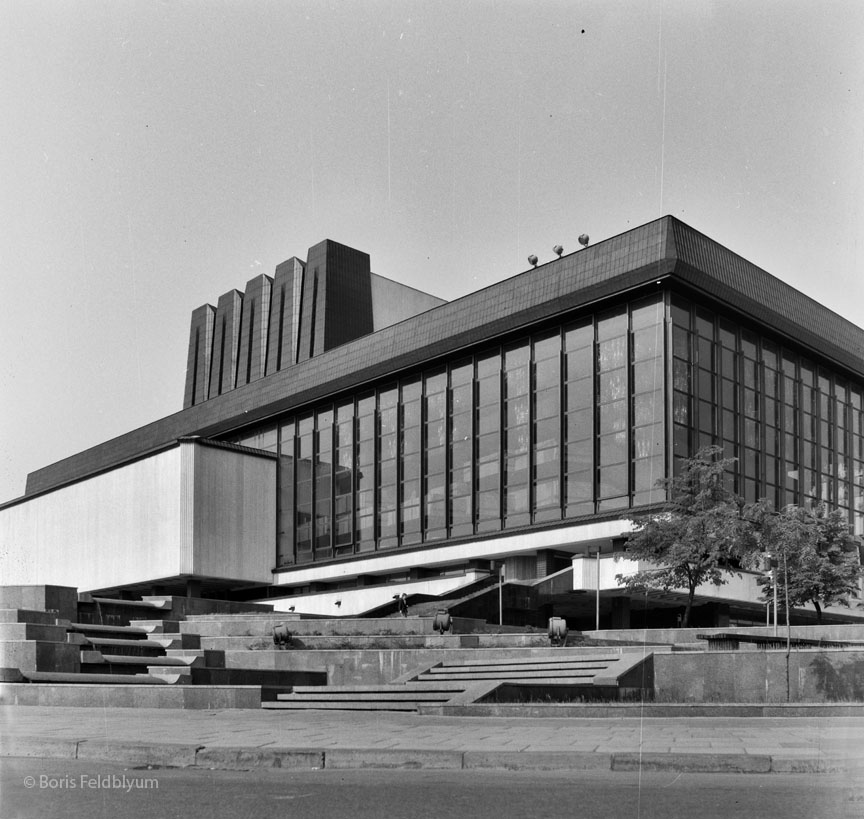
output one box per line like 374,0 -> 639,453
231,294 -> 666,566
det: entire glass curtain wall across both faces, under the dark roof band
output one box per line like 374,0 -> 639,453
232,293 -> 864,566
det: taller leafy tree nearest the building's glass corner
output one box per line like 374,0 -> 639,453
617,446 -> 752,628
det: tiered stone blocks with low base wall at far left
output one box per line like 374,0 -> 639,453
0,596 -> 327,708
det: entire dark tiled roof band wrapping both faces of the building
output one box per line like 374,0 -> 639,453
26,216 -> 864,495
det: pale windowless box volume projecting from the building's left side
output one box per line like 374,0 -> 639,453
0,442 -> 276,591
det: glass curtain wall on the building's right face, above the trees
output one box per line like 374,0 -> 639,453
671,296 -> 864,534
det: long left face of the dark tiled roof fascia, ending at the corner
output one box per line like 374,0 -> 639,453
26,219 -> 674,496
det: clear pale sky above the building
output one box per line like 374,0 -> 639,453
0,0 -> 864,500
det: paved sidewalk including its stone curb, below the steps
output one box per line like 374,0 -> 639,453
0,706 -> 864,781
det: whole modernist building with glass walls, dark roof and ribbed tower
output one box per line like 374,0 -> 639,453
0,217 -> 864,625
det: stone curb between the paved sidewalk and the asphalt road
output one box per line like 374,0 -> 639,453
0,737 -> 864,774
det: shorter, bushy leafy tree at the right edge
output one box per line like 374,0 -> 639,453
745,501 -> 862,623
